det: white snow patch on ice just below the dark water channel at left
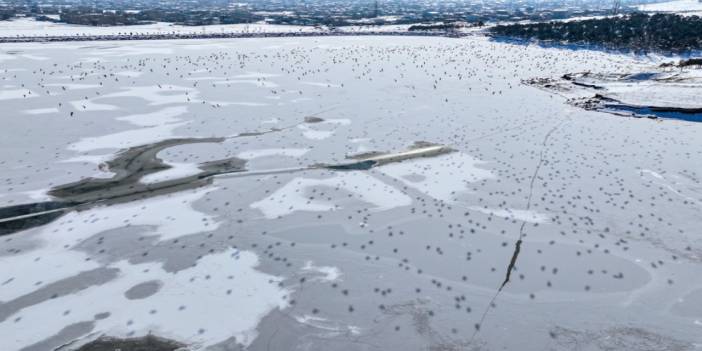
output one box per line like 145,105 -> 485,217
0,190 -> 219,306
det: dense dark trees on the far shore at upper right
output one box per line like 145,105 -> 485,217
490,13 -> 702,52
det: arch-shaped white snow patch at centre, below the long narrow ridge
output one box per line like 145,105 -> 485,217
251,172 -> 412,219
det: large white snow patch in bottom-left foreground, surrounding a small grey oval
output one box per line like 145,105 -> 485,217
0,249 -> 290,350
